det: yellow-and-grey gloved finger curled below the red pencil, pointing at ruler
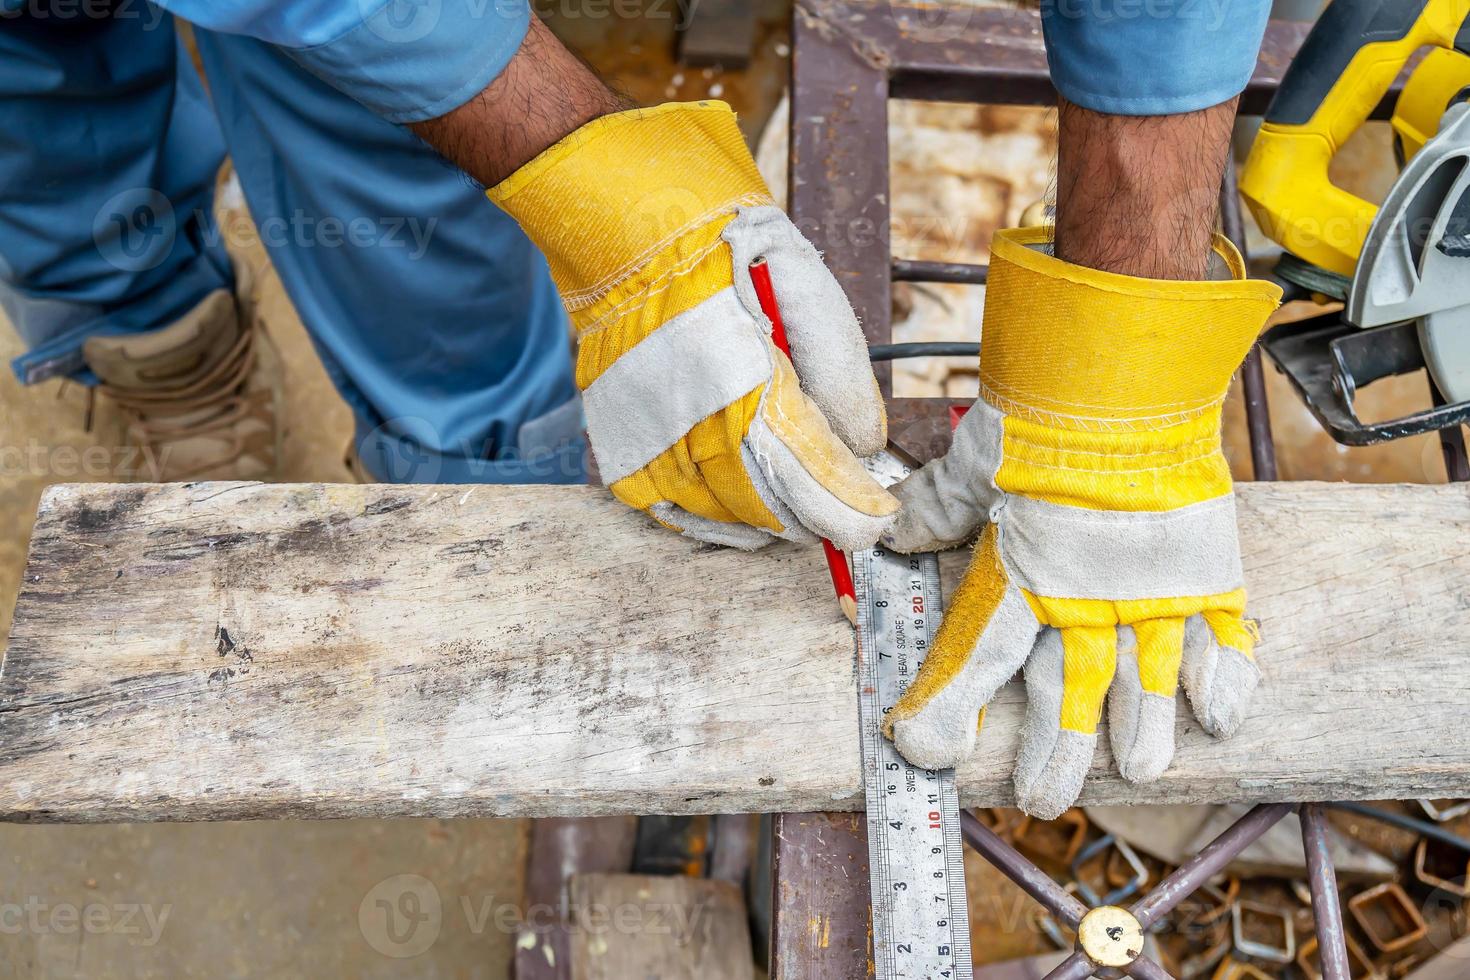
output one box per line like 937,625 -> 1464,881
745,337 -> 898,550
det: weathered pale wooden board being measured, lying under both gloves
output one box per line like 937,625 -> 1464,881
0,483 -> 1470,821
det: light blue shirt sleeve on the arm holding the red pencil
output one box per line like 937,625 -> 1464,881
147,0 -> 531,123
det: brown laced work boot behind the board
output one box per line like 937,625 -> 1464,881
82,268 -> 281,482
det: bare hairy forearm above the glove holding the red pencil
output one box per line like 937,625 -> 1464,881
410,18 -> 631,187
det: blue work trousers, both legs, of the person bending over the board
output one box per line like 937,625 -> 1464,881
0,4 -> 585,482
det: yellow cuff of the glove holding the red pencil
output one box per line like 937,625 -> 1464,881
487,101 -> 772,311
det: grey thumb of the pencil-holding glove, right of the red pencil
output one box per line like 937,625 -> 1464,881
723,206 -> 888,455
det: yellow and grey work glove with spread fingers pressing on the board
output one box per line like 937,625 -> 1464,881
888,228 -> 1280,818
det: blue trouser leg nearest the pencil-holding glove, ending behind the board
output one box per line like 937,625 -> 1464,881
197,31 -> 585,483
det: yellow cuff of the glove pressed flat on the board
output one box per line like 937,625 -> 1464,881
980,228 -> 1280,430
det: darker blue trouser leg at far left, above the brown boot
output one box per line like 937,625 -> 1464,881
0,3 -> 231,383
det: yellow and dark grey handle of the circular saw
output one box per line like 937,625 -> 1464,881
1241,0 -> 1470,276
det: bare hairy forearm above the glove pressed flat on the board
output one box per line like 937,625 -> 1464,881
1055,100 -> 1235,279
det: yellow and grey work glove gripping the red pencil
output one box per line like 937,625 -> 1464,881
490,101 -> 898,548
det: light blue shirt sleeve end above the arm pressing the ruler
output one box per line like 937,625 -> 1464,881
1041,0 -> 1272,116
